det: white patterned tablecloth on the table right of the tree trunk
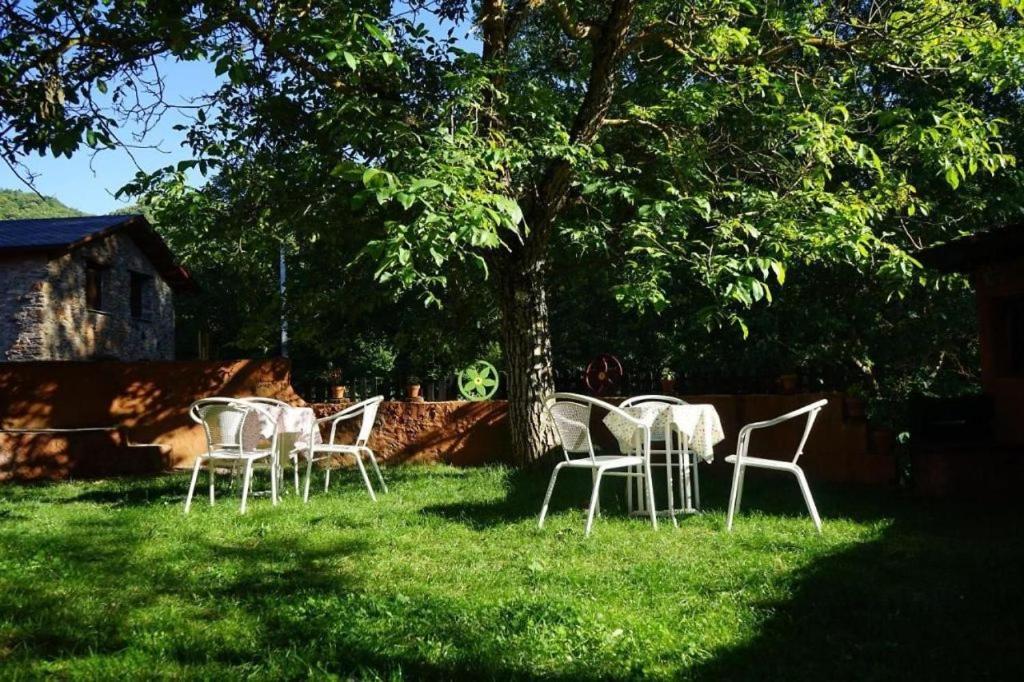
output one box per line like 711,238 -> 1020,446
604,402 -> 725,462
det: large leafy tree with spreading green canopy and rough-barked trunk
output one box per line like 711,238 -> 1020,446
0,0 -> 1024,460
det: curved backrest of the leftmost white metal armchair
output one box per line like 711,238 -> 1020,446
188,397 -> 278,452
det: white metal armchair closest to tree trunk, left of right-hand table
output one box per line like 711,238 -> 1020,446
538,393 -> 657,537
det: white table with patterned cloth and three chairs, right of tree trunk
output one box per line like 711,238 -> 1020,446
539,393 -> 828,536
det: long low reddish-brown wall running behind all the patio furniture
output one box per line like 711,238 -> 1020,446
0,359 -> 895,482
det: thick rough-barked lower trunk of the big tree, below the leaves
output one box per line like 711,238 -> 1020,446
497,252 -> 555,466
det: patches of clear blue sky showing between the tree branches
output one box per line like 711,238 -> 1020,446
0,7 -> 478,215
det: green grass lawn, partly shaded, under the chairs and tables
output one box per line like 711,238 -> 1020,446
0,467 -> 1024,680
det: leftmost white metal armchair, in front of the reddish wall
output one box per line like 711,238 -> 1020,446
185,397 -> 278,514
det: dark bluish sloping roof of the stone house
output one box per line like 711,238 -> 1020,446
0,215 -> 197,291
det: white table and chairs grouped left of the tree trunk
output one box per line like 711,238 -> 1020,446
185,395 -> 387,513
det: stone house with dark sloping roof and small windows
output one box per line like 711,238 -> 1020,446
0,215 -> 195,361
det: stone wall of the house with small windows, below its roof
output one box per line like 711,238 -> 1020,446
0,233 -> 174,361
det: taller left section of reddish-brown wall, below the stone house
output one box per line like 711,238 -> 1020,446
0,359 -> 301,480
